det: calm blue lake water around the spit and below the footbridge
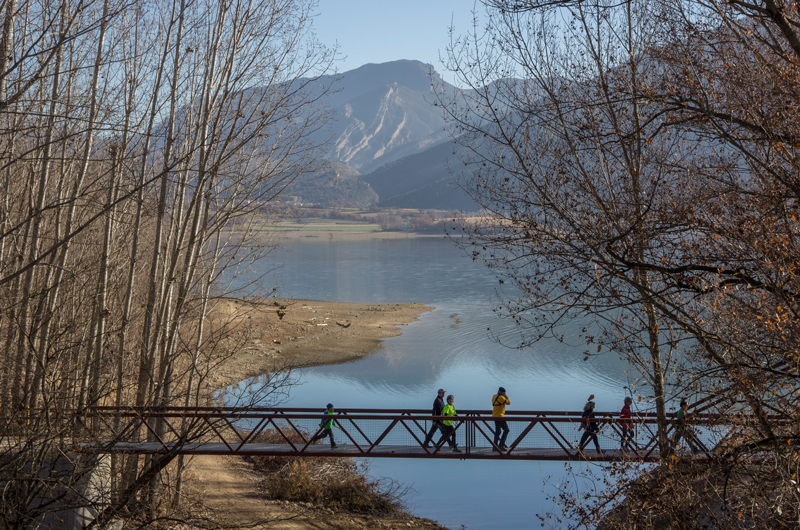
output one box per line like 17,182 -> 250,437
228,239 -> 629,530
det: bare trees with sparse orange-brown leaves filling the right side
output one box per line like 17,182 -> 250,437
444,0 -> 800,527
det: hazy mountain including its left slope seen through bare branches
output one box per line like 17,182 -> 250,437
159,60 -> 510,211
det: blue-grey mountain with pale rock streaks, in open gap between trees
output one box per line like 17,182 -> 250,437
284,59 -> 477,211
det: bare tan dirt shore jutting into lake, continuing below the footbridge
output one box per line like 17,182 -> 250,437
186,298 -> 447,530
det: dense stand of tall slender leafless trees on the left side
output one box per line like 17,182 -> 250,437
0,0 -> 333,526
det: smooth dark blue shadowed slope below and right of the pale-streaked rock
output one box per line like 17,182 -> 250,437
361,141 -> 480,212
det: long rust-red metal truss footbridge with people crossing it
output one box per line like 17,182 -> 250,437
75,407 -> 746,462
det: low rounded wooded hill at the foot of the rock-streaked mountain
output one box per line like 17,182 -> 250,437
284,160 -> 378,208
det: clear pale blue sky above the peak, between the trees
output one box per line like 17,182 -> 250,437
314,0 -> 488,73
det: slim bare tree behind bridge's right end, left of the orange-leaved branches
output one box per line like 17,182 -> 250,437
441,2 -> 685,455
